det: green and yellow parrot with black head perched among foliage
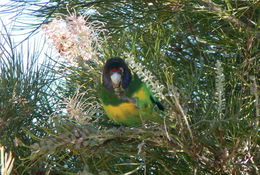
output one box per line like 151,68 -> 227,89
99,57 -> 164,126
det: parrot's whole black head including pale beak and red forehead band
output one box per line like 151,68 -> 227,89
103,57 -> 131,91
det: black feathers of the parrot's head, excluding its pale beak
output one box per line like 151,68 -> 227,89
103,57 -> 131,91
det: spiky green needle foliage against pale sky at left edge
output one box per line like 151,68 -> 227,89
0,24 -> 57,174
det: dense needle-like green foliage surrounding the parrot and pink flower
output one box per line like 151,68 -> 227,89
0,0 -> 260,174
